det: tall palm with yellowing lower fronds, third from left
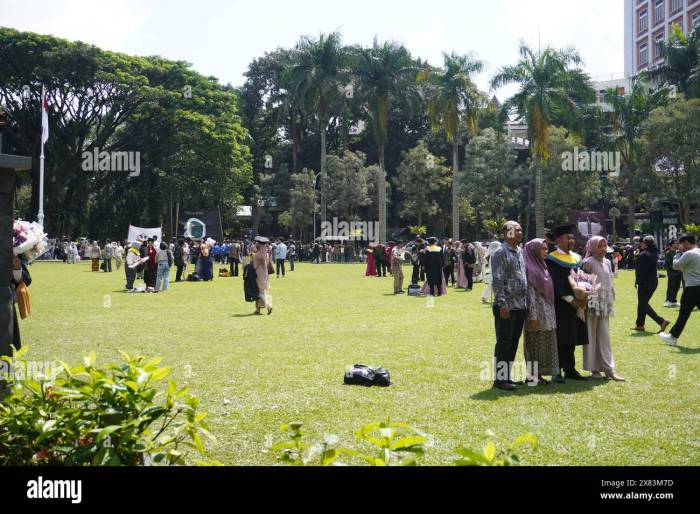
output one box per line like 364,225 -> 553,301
418,53 -> 488,241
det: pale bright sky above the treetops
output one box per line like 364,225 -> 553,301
0,0 -> 624,99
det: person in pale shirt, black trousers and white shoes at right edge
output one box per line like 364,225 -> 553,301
659,234 -> 700,346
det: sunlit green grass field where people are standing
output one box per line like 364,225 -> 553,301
21,262 -> 700,466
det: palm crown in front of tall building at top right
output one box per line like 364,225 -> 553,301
651,24 -> 700,98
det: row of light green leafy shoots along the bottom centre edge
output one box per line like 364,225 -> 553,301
270,420 -> 537,466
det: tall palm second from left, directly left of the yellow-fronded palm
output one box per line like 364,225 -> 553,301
353,38 -> 418,241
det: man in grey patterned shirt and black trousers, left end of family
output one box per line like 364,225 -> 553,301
491,221 -> 527,391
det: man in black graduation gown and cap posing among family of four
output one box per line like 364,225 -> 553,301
547,225 -> 588,382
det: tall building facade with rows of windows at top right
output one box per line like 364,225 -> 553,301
625,0 -> 700,77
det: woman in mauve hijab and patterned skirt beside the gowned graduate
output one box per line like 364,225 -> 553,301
524,239 -> 559,385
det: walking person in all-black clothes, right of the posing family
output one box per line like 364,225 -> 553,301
632,236 -> 670,332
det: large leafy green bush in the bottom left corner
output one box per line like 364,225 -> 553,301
0,347 -> 213,466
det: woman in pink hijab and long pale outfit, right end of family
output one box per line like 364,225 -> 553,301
583,236 -> 625,382
